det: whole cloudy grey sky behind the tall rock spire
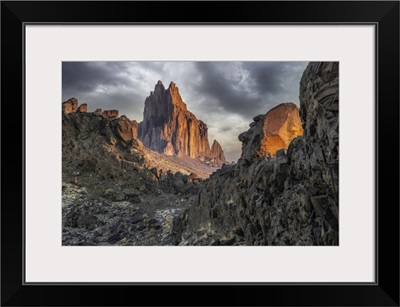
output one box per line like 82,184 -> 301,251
62,62 -> 307,161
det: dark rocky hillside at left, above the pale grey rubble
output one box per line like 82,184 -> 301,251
62,112 -> 144,181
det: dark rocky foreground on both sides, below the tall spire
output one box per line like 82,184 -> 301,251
62,63 -> 339,245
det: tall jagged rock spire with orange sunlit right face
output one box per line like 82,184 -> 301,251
139,81 -> 223,164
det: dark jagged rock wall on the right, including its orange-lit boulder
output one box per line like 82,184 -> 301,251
180,62 -> 339,245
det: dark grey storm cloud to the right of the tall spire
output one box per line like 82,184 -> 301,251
195,62 -> 306,118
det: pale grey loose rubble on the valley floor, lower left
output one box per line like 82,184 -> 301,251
62,179 -> 193,246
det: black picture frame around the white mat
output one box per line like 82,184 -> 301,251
1,1 -> 400,306
